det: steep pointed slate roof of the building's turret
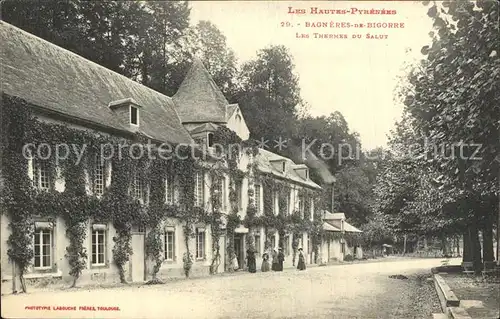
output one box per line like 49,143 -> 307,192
172,57 -> 229,123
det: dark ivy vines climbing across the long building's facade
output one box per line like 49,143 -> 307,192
0,95 -> 321,291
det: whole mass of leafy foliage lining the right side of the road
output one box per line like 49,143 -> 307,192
376,1 -> 500,269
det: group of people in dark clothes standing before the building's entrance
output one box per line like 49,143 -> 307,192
232,247 -> 306,273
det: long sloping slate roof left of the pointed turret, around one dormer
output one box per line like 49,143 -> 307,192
0,21 -> 192,143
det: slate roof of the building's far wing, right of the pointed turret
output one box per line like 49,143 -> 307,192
255,149 -> 321,189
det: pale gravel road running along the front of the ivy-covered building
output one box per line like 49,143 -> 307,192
2,259 -> 440,319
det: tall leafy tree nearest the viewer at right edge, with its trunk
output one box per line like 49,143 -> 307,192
394,1 -> 500,271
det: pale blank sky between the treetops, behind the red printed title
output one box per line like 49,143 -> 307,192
191,0 -> 432,149
